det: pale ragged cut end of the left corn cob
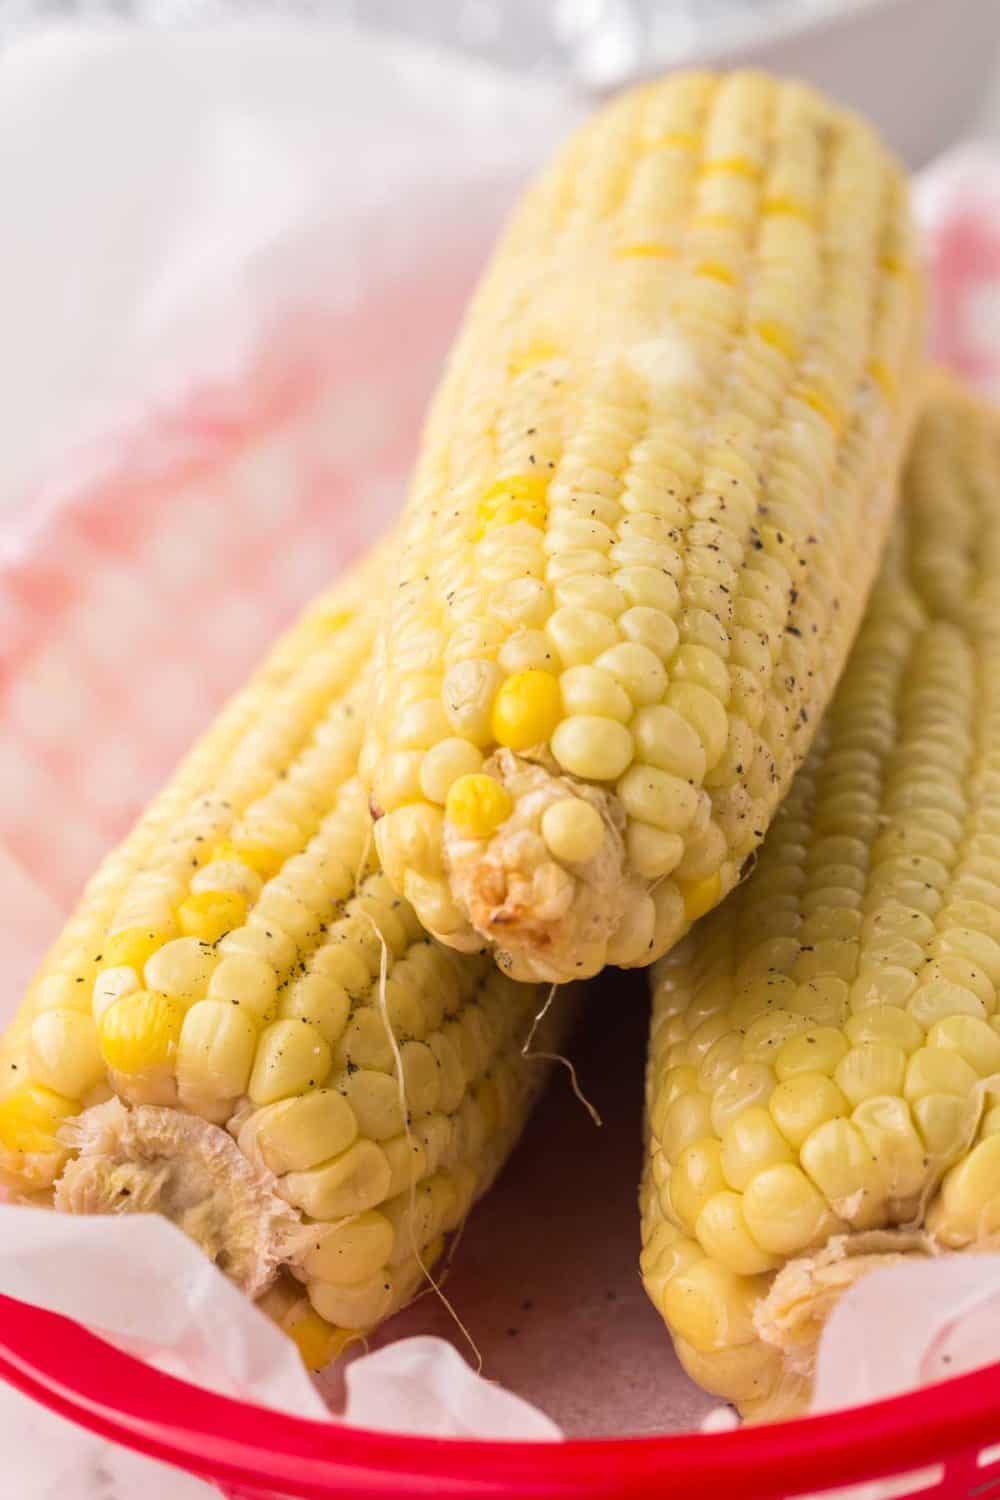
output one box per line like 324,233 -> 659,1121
54,1098 -> 301,1298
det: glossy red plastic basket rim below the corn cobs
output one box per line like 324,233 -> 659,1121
0,1296 -> 1000,1500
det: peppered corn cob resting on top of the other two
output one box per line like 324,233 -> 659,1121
363,74 -> 922,981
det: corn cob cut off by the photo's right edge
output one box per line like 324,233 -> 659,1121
642,386 -> 1000,1415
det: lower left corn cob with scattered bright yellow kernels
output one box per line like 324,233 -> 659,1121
0,554 -> 568,1362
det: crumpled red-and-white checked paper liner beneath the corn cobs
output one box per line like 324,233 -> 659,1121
0,14 -> 1000,1500
